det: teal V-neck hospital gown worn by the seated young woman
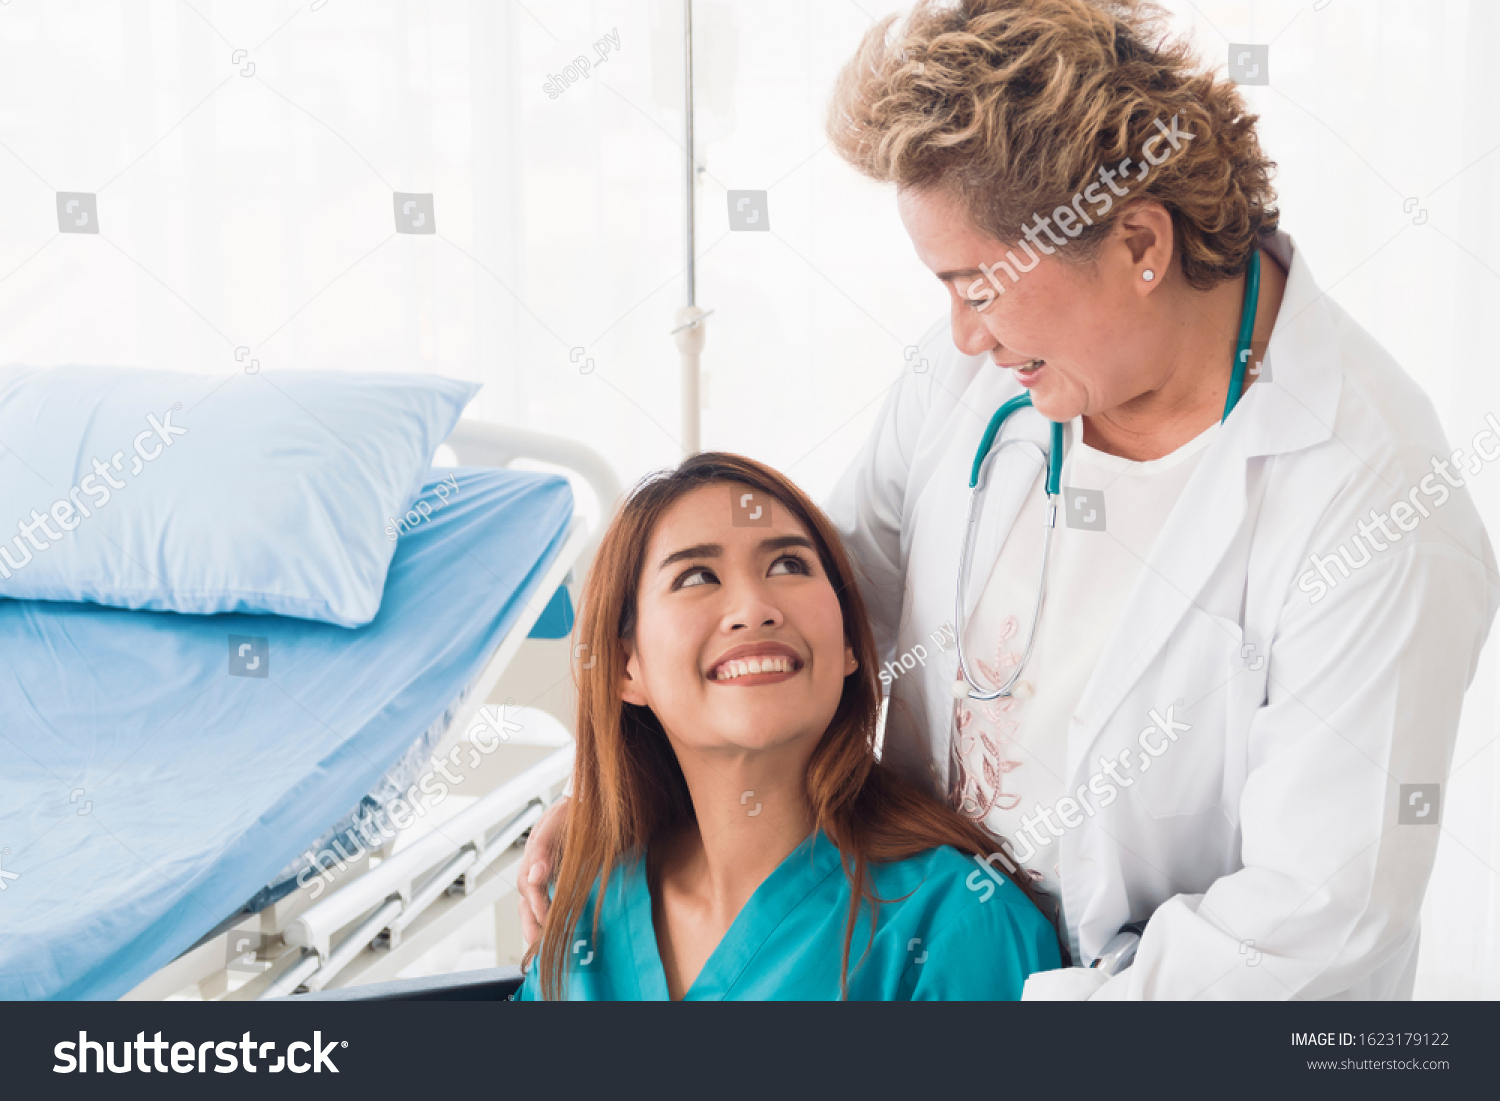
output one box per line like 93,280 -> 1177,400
515,831 -> 1062,1001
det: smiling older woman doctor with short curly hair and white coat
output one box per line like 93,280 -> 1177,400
522,0 -> 1500,999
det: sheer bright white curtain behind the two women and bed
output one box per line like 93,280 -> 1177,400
0,0 -> 1500,998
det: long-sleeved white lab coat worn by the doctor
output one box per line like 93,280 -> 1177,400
828,233 -> 1500,999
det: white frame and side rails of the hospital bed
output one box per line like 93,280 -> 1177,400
125,420 -> 621,1001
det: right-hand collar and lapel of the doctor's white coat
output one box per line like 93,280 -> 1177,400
1068,231 -> 1343,782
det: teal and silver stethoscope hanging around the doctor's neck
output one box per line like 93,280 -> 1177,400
953,249 -> 1260,701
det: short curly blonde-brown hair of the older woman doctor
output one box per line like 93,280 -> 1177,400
828,0 -> 1280,290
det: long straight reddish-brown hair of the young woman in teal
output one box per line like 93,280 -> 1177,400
522,452 -> 1046,999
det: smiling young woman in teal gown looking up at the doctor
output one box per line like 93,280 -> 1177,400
518,453 -> 1061,1001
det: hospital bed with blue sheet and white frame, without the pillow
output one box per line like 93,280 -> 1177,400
0,422 -> 620,999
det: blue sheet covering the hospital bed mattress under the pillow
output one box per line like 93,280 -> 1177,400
0,468 -> 573,999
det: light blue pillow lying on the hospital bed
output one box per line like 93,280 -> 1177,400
0,366 -> 479,627
